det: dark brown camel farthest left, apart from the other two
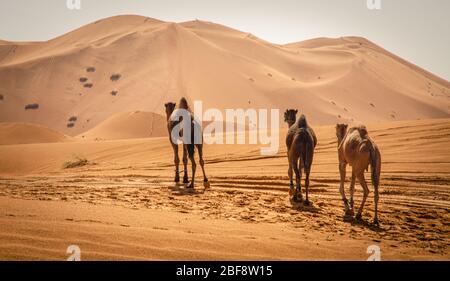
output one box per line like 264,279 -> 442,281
165,98 -> 209,189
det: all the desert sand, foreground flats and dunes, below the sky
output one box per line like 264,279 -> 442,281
0,16 -> 450,260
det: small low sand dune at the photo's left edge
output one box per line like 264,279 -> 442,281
0,123 -> 71,145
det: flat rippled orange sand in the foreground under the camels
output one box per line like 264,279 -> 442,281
0,119 -> 450,260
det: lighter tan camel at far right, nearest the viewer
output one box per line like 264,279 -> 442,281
336,124 -> 381,225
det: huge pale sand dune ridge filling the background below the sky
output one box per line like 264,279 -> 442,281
0,16 -> 450,136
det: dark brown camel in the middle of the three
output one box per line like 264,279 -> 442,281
285,110 -> 317,205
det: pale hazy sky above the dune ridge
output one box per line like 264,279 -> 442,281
0,0 -> 450,80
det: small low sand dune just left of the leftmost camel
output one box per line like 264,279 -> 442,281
78,111 -> 168,140
